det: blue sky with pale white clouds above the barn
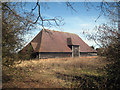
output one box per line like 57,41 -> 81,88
25,2 -> 107,47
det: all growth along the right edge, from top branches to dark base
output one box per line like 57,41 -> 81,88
87,2 -> 120,89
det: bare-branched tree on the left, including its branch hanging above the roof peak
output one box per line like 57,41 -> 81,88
2,0 -> 64,64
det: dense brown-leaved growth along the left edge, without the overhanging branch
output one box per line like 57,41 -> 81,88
2,2 -> 34,66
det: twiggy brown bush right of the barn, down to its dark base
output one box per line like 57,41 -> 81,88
88,24 -> 120,89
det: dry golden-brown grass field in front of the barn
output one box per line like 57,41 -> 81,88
3,56 -> 107,89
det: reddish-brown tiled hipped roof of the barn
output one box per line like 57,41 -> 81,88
21,29 -> 96,52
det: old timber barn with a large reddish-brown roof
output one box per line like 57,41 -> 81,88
20,29 -> 96,58
